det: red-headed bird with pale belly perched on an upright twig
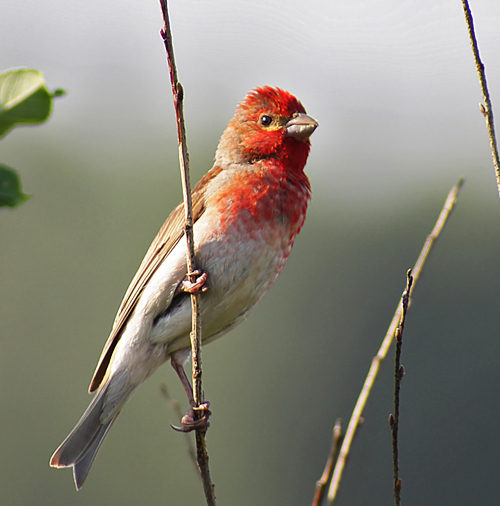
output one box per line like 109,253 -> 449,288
50,86 -> 318,490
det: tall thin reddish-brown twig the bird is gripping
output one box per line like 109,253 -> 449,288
160,0 -> 215,506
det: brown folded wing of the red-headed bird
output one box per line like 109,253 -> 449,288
89,167 -> 222,392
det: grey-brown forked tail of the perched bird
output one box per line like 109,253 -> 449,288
50,383 -> 120,489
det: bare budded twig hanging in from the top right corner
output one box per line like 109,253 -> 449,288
462,0 -> 500,196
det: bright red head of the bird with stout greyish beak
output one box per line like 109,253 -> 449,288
216,86 -> 318,170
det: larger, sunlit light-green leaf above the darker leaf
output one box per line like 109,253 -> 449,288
0,69 -> 64,137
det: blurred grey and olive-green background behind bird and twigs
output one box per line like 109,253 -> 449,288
0,0 -> 500,506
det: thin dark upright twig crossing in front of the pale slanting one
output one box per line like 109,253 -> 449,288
389,269 -> 413,506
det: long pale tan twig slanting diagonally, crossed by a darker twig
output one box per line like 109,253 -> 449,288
328,179 -> 463,505
